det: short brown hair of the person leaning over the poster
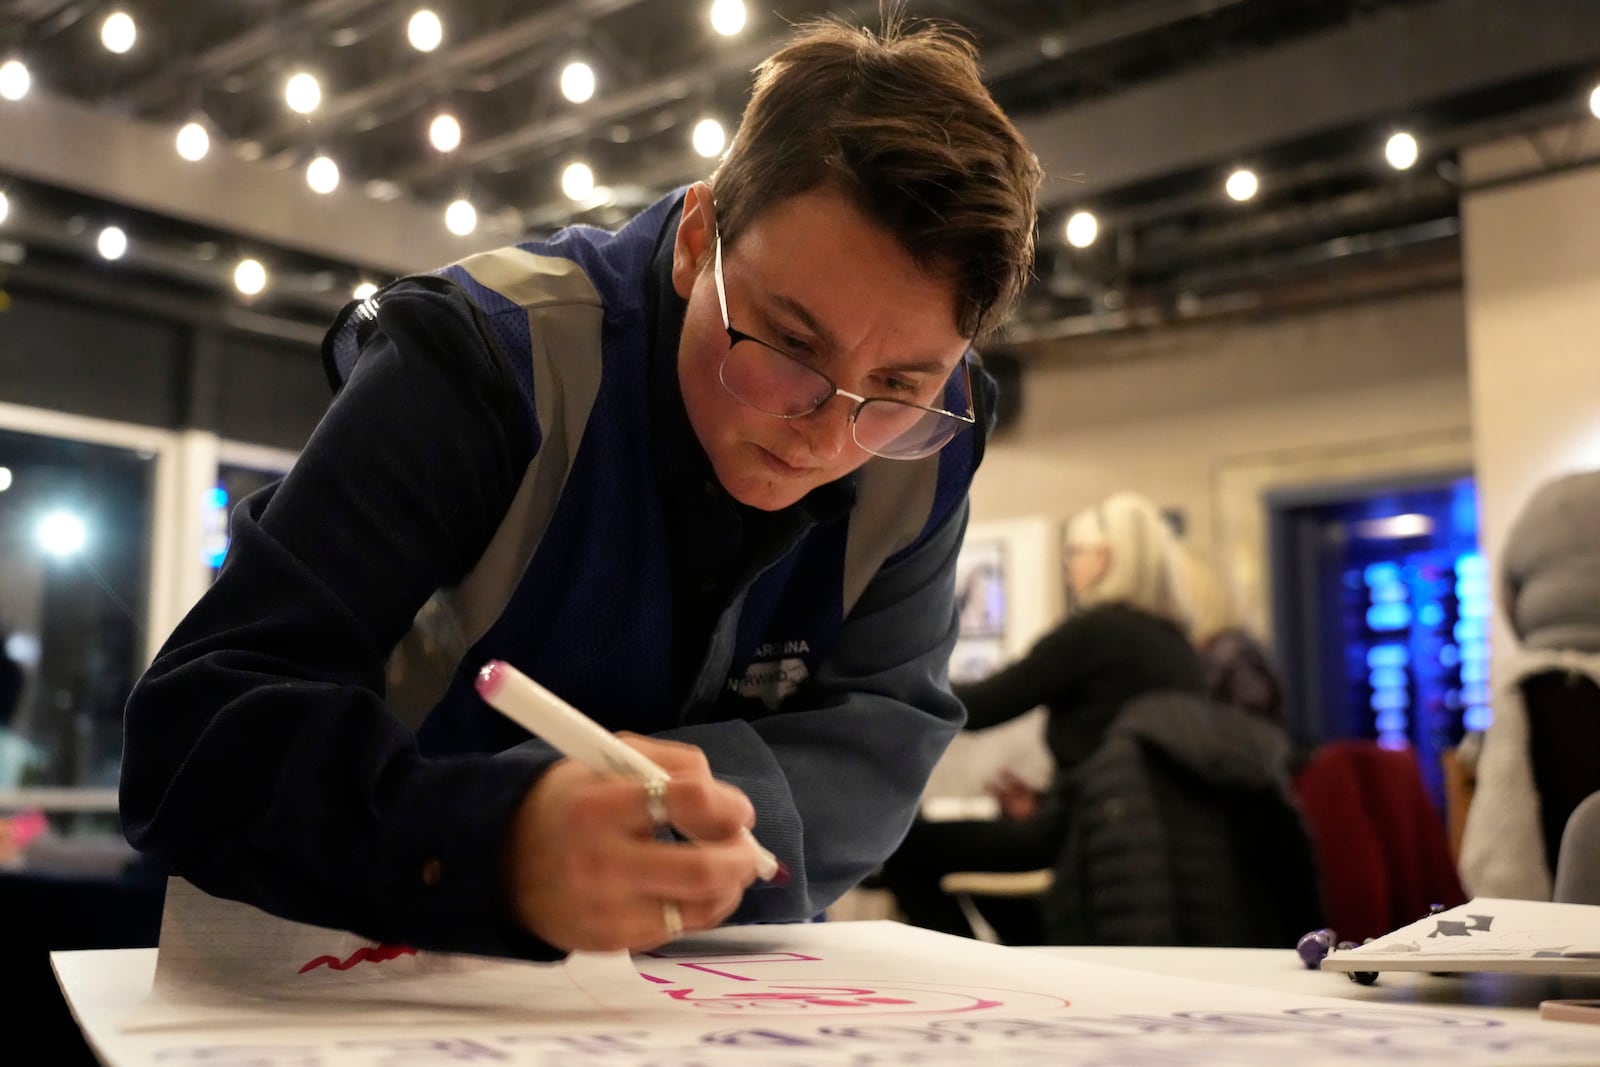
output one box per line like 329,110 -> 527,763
710,16 -> 1040,339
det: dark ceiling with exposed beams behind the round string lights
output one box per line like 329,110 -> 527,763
0,0 -> 1600,346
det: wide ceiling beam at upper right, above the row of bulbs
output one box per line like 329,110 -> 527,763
1018,0 -> 1600,208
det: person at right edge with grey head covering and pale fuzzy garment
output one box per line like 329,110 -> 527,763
1459,470 -> 1600,901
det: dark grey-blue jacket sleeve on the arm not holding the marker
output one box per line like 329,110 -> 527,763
656,502 -> 966,921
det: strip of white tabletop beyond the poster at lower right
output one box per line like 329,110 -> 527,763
1027,945 -> 1600,1025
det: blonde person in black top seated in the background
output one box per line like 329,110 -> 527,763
878,493 -> 1206,934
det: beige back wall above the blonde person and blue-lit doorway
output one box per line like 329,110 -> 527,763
973,291 -> 1472,643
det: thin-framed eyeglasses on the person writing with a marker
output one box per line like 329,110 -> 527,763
712,234 -> 978,459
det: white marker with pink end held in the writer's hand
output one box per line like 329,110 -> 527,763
477,659 -> 779,881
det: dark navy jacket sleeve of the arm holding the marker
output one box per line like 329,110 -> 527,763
122,283 -> 563,955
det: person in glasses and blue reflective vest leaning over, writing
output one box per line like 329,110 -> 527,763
112,18 -> 1040,958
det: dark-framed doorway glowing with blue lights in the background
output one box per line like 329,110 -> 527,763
1267,474 -> 1490,809
